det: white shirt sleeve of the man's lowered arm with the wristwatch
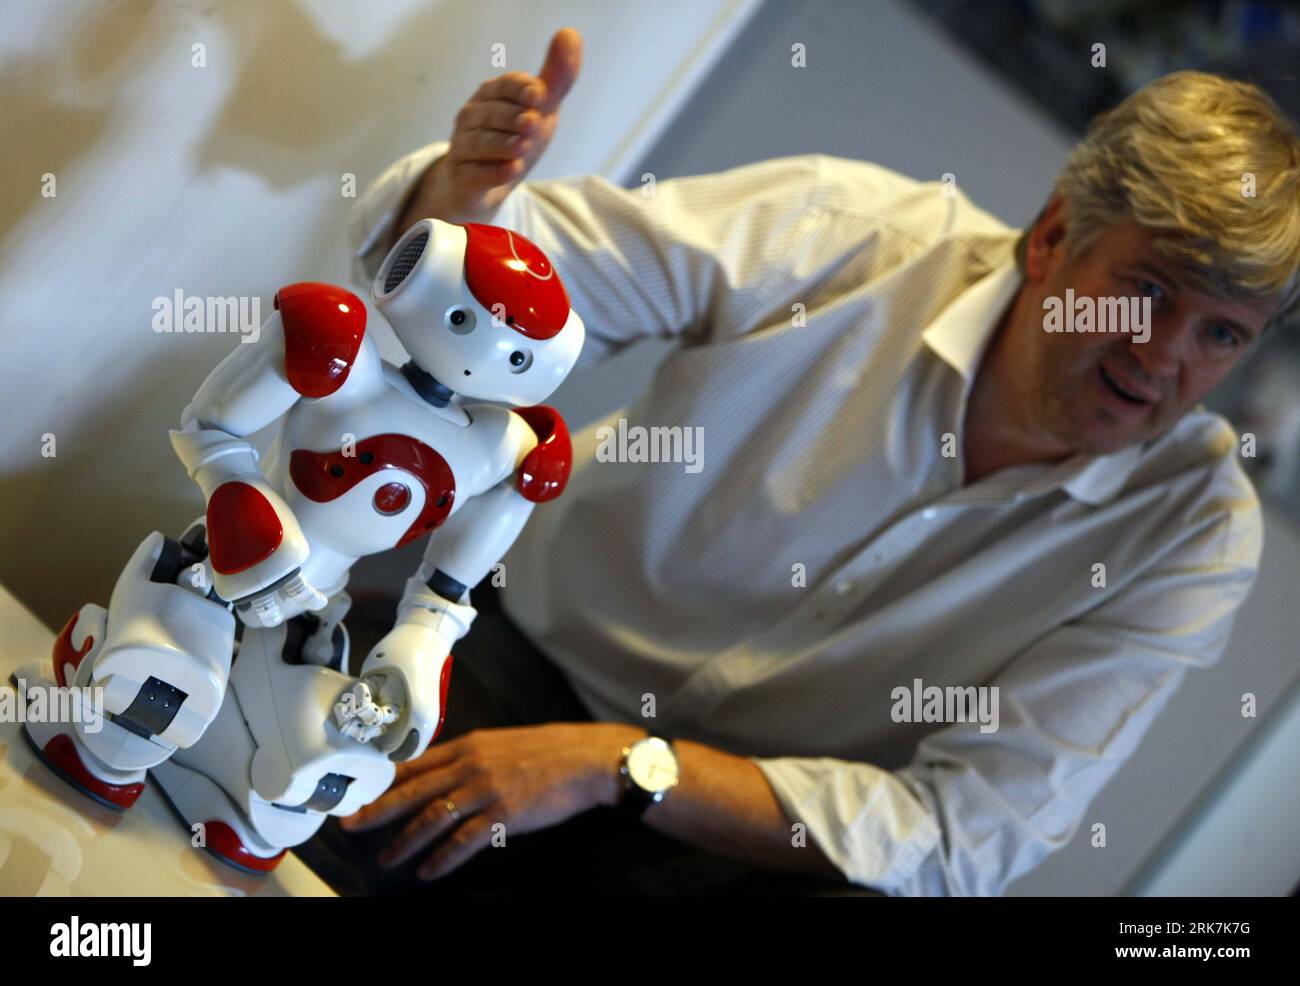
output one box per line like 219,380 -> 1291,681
751,500 -> 1262,896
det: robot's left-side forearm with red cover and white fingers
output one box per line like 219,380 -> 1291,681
208,475 -> 329,627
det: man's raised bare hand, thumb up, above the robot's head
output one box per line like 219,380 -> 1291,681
393,27 -> 582,241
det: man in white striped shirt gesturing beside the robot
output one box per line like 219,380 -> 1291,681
322,30 -> 1300,894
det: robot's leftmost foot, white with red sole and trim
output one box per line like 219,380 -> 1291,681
9,661 -> 144,812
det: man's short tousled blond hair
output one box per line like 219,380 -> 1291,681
1015,72 -> 1300,328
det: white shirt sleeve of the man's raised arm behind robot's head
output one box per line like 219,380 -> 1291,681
348,140 -> 820,364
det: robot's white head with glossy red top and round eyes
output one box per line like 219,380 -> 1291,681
372,219 -> 586,407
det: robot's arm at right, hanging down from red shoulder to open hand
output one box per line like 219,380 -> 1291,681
335,406 -> 573,760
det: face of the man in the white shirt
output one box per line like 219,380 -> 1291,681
1010,200 -> 1274,454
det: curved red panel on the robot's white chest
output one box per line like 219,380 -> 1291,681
289,434 -> 456,548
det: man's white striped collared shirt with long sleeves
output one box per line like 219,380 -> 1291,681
350,142 -> 1262,894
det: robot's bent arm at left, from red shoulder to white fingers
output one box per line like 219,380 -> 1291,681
170,284 -> 365,626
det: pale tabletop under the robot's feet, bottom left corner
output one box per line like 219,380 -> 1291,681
0,585 -> 334,896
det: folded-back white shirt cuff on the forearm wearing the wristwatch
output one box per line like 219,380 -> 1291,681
749,757 -> 940,894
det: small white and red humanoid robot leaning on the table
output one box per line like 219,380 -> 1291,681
14,219 -> 585,873
